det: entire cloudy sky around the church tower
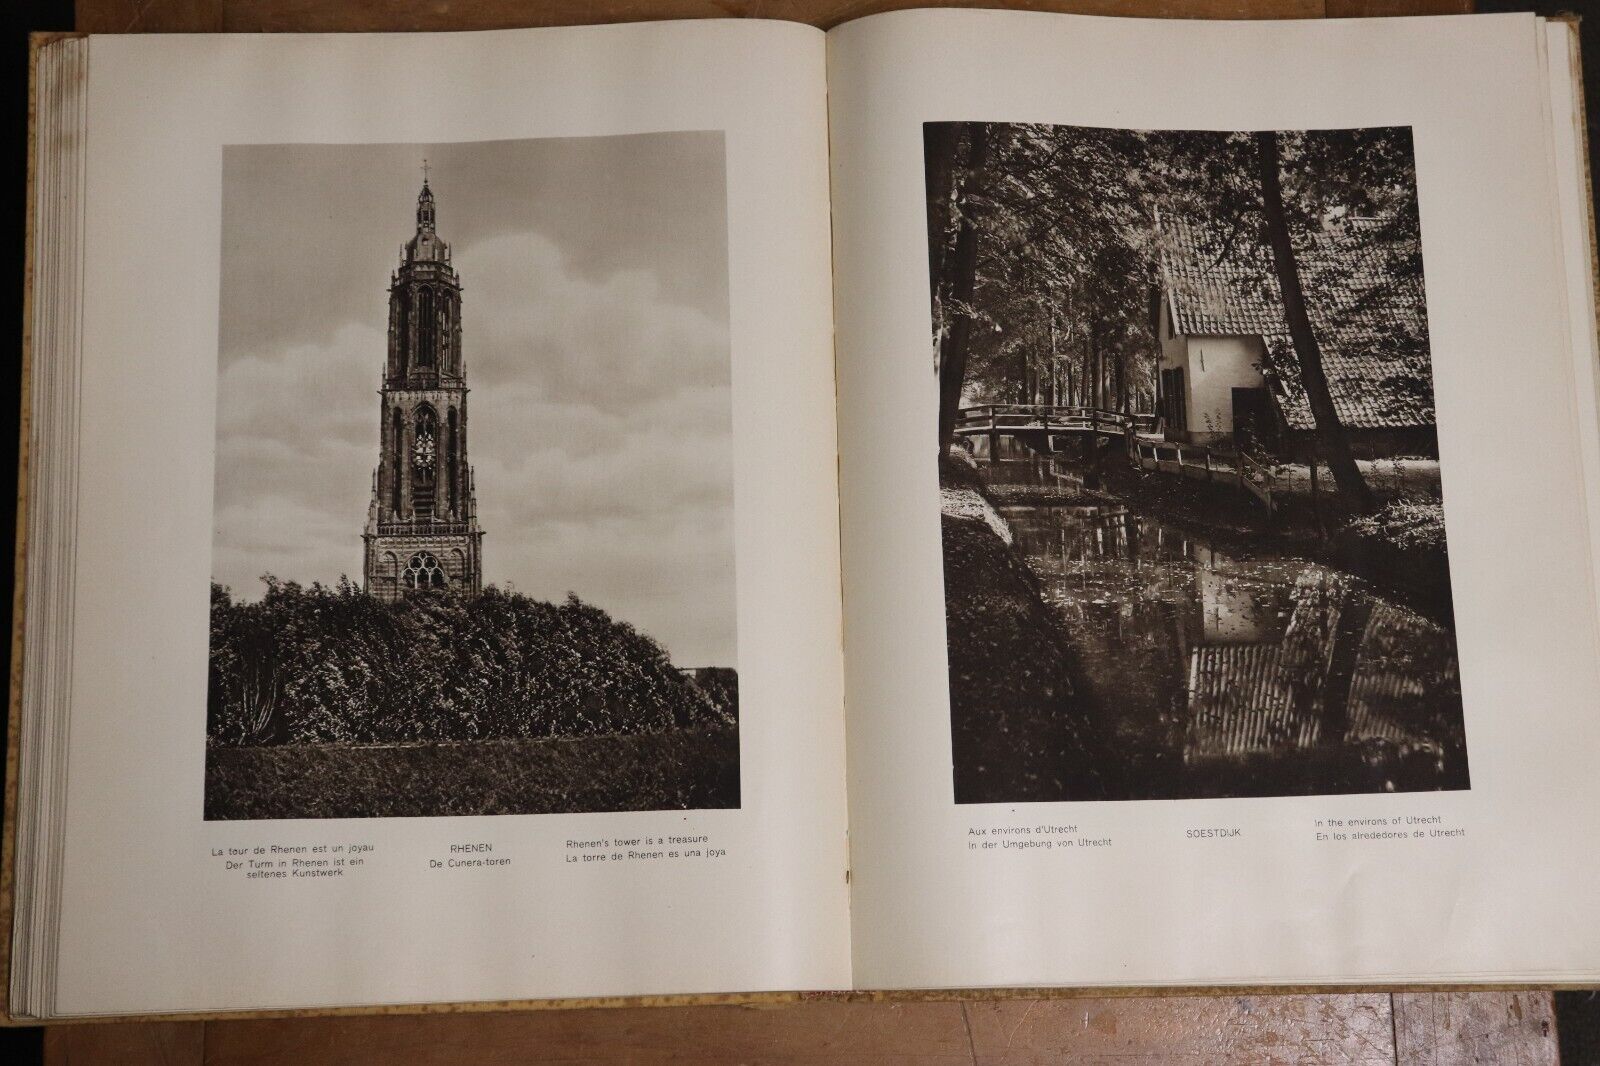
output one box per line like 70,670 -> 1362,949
211,133 -> 736,666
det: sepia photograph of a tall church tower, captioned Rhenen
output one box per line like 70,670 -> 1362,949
205,131 -> 739,820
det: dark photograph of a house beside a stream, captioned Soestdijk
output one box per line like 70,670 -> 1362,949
923,122 -> 1469,804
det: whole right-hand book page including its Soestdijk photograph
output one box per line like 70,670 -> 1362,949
829,11 -> 1600,988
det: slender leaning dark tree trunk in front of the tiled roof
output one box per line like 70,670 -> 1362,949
1256,130 -> 1376,514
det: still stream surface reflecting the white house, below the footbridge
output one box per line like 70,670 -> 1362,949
1004,476 -> 1467,799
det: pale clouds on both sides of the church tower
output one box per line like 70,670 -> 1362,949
213,199 -> 736,664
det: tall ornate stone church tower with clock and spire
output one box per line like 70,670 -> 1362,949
362,170 -> 483,600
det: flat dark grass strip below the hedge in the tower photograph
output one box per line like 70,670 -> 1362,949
205,727 -> 739,820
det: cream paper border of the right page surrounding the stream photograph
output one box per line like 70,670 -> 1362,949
829,11 -> 1600,988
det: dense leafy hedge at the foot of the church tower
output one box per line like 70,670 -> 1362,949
206,578 -> 738,746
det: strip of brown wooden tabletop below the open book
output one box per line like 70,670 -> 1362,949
45,992 -> 1558,1066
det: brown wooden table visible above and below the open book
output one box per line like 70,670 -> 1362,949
45,0 -> 1558,1066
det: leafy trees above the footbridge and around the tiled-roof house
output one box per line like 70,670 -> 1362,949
925,123 -> 1429,515
